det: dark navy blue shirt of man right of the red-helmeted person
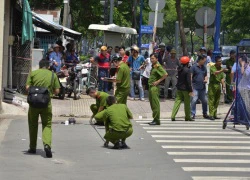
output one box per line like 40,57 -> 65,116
190,63 -> 207,90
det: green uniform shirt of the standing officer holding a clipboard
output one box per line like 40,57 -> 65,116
116,62 -> 130,89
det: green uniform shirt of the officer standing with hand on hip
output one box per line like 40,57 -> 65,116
148,63 -> 167,86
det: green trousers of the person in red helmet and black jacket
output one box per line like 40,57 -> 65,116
171,90 -> 191,121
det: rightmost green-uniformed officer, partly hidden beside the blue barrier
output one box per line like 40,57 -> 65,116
225,50 -> 236,104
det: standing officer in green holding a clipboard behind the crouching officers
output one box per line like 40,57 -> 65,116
101,56 -> 130,104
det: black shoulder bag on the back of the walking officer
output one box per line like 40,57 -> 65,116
27,72 -> 54,108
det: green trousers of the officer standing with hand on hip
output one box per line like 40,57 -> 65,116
148,86 -> 160,122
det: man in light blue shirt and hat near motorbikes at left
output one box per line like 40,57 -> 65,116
49,44 -> 63,72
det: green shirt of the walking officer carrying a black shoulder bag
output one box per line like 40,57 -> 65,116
26,69 -> 60,96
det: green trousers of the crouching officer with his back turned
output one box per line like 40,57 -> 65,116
104,127 -> 133,144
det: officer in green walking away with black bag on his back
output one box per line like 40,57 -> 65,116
26,59 -> 60,158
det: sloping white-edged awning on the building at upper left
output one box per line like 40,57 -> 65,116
32,12 -> 82,40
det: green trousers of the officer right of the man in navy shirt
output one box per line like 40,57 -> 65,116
208,83 -> 221,117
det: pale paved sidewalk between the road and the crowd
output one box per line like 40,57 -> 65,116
52,95 -> 230,118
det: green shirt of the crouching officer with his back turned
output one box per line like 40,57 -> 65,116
104,104 -> 133,132
